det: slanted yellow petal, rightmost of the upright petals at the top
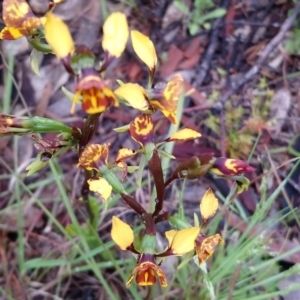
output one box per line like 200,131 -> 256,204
131,30 -> 157,71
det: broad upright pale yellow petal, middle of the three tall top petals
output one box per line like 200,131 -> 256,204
102,12 -> 129,57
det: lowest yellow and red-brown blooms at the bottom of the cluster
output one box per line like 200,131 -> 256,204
111,189 -> 223,286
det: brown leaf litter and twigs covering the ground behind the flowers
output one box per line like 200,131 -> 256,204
0,0 -> 300,299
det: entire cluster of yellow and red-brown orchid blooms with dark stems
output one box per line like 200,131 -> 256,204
0,0 -> 254,286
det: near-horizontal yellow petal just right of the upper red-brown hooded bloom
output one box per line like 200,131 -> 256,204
115,83 -> 149,111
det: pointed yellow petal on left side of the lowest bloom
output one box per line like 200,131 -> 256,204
111,216 -> 134,250
